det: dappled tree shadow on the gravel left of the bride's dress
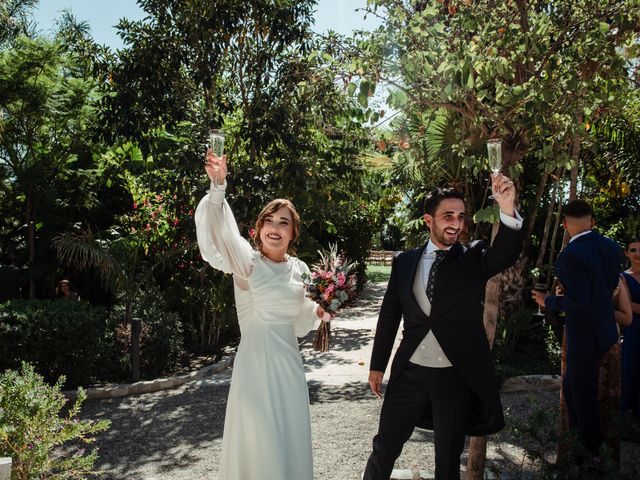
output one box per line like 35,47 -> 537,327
82,384 -> 229,479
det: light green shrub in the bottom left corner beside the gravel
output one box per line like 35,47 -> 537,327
0,363 -> 110,480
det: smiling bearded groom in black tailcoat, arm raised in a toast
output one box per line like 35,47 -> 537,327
364,175 -> 522,480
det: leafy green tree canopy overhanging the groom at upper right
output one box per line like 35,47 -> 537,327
343,0 -> 640,248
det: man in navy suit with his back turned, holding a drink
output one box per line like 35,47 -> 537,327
531,200 -> 623,455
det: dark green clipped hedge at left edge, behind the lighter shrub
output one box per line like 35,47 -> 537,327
0,300 -> 107,387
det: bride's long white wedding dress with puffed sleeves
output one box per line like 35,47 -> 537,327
195,181 -> 317,480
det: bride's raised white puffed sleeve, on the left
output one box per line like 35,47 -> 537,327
195,182 -> 254,279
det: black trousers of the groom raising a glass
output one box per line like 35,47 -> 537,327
363,362 -> 473,480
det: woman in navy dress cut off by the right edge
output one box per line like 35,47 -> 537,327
621,239 -> 640,421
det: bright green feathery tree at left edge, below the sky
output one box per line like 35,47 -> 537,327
0,36 -> 102,298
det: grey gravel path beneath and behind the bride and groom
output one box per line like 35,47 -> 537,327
82,284 -> 638,480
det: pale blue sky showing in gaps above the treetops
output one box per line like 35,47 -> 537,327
34,0 -> 378,49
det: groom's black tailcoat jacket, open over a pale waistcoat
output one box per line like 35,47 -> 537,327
370,224 -> 523,436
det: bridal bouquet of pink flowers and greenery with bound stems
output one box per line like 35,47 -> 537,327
302,245 -> 356,352
